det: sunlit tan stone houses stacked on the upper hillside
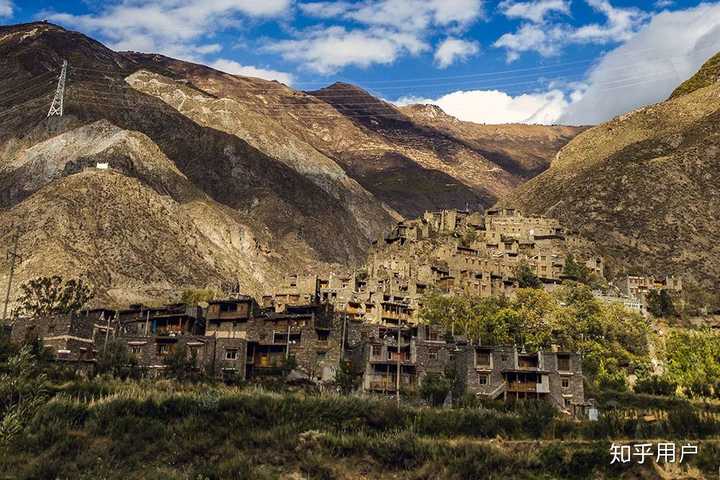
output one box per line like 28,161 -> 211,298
262,208 -> 604,325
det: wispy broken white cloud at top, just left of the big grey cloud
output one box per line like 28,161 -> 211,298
493,0 -> 648,62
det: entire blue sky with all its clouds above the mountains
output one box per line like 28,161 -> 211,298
0,0 -> 720,124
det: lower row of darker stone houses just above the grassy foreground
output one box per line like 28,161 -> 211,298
11,296 -> 586,414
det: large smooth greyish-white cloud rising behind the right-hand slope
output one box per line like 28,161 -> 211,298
561,4 -> 720,124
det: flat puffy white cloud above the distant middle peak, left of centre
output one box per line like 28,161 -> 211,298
266,27 -> 428,74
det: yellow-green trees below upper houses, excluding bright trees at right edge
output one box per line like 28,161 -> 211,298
421,282 -> 650,389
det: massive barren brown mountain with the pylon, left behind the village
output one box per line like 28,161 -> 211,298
0,22 -> 570,303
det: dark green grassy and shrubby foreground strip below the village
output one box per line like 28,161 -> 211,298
0,379 -> 720,480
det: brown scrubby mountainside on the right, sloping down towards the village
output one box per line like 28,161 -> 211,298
501,52 -> 720,291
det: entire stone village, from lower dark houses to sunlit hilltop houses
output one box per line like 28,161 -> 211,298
4,209 -> 682,416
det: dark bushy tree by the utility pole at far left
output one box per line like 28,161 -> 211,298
19,275 -> 94,317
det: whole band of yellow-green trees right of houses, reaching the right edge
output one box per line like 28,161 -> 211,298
421,282 -> 720,398
